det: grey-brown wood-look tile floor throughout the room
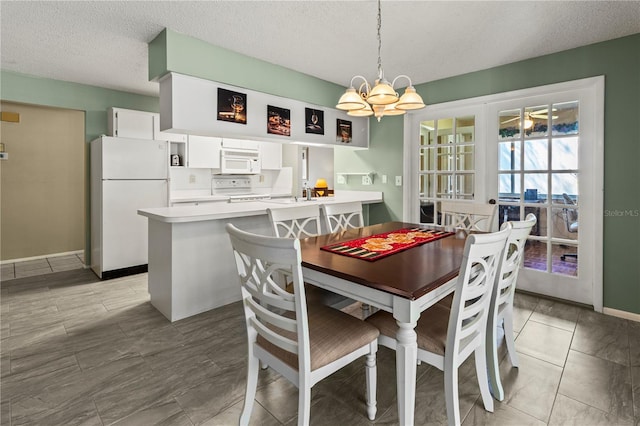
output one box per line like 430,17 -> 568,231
0,269 -> 640,426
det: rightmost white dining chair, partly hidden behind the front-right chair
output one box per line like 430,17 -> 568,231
487,213 -> 537,401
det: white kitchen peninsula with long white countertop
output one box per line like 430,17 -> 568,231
138,191 -> 382,321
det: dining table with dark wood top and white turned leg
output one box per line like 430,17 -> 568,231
300,222 -> 465,425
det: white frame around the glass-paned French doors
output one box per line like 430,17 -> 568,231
403,76 -> 604,312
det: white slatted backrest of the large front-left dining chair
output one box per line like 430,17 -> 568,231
226,224 -> 311,368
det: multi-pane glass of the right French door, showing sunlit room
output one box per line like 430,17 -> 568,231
497,100 -> 581,277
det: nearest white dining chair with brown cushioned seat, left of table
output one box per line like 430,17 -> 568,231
226,224 -> 379,426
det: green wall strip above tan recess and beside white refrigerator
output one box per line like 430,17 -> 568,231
0,71 -> 159,264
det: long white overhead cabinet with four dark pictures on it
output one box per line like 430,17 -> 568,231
160,73 -> 369,148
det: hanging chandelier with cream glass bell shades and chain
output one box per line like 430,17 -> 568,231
336,0 -> 425,121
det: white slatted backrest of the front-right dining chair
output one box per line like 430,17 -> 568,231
445,227 -> 510,363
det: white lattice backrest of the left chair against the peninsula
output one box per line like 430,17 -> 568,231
267,204 -> 321,238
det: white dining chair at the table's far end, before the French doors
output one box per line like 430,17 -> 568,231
440,201 -> 498,232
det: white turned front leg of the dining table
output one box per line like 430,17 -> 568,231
396,321 -> 418,426
